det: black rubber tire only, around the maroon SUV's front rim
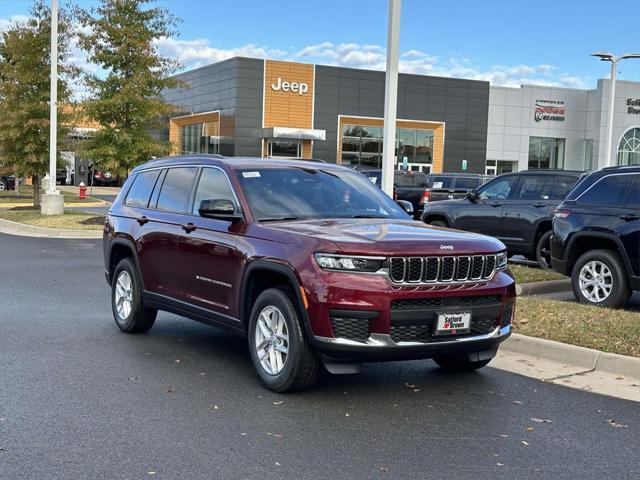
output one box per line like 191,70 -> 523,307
248,288 -> 320,393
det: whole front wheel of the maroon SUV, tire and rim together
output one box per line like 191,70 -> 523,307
248,288 -> 320,393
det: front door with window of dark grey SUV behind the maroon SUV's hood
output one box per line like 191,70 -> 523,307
450,175 -> 518,239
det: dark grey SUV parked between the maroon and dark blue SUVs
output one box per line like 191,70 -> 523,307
422,170 -> 582,268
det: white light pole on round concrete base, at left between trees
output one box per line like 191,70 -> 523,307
40,0 -> 64,215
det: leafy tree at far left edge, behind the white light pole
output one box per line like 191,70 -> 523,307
0,0 -> 77,207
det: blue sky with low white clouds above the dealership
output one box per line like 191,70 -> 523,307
0,0 -> 640,88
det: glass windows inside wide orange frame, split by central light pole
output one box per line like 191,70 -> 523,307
341,125 -> 433,168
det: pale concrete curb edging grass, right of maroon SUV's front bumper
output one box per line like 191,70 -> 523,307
501,333 -> 640,378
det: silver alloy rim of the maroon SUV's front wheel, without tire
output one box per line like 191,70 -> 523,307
254,305 -> 289,375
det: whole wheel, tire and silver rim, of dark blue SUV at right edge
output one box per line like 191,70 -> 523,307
571,250 -> 631,307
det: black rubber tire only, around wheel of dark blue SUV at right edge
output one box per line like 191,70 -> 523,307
571,249 -> 631,307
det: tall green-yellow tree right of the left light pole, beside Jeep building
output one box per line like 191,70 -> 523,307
78,0 -> 180,174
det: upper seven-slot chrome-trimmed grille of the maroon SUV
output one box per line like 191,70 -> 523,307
389,255 -> 497,283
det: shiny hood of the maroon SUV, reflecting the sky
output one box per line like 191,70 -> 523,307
260,219 -> 505,255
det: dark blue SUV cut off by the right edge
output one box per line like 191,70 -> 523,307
551,166 -> 640,306
